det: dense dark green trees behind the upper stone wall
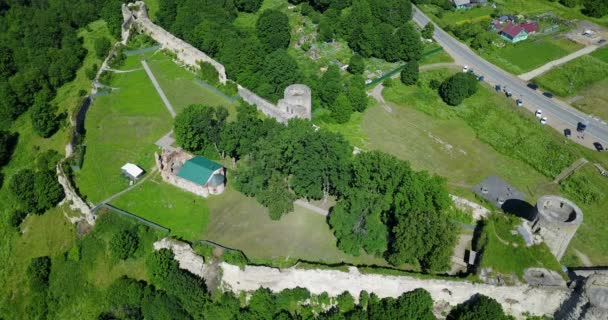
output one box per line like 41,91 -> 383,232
157,0 -> 423,123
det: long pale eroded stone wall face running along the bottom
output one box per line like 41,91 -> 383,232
154,239 -> 572,320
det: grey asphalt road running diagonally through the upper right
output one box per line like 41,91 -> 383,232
413,7 -> 608,144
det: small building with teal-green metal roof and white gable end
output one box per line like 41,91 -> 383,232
177,156 -> 225,186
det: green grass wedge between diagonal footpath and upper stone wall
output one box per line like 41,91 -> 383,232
148,54 -> 237,114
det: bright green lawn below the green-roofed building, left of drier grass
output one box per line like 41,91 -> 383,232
112,173 -> 209,241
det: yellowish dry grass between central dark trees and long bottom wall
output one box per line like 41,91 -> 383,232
204,188 -> 386,265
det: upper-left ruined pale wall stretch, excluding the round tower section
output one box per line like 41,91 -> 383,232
123,1 -> 227,84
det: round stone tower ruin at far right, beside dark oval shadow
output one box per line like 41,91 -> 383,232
532,196 -> 583,261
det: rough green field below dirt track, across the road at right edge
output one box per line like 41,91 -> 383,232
533,56 -> 608,97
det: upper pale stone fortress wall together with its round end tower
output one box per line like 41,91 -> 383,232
122,1 -> 312,123
